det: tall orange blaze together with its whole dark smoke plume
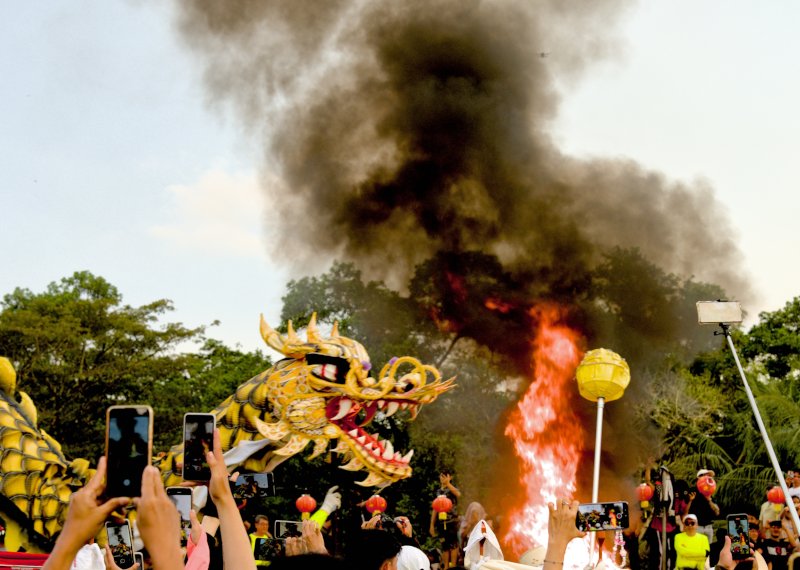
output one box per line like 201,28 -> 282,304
173,0 -> 748,551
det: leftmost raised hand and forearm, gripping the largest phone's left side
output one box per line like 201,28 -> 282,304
43,457 -> 130,570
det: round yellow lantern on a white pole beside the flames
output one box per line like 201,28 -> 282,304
575,348 -> 631,402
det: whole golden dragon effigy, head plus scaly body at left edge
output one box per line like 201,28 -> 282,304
0,315 -> 454,551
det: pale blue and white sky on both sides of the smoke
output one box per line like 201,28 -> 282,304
0,0 -> 800,350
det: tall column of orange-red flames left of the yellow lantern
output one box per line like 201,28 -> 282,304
503,305 -> 584,555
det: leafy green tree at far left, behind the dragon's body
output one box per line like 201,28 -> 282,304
0,271 -> 268,459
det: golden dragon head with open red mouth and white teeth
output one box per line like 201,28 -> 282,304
196,314 -> 454,486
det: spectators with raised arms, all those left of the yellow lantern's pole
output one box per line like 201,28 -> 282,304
36,432 -> 584,570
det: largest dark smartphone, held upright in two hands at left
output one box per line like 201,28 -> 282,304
106,406 -> 153,497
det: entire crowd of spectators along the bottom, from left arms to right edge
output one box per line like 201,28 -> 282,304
36,432 -> 800,570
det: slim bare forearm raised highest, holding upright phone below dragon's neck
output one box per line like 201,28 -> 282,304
206,429 -> 256,570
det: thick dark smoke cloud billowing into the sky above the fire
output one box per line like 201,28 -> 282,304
179,0 -> 750,524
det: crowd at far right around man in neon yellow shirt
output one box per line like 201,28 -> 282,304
631,468 -> 800,570
